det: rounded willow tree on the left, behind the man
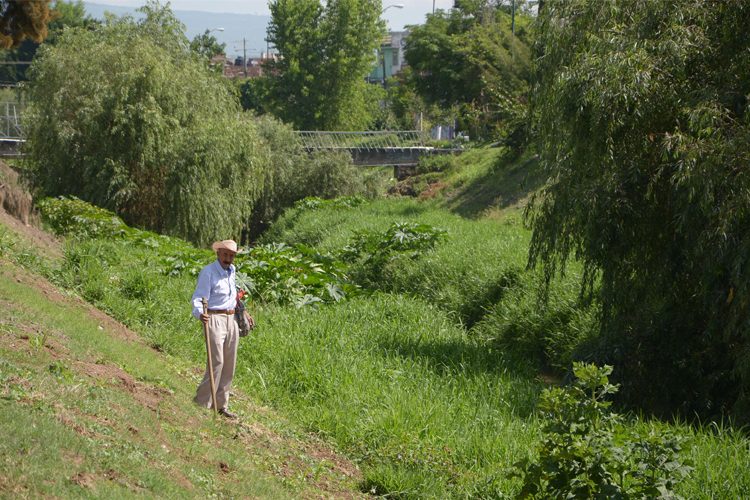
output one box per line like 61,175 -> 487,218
25,2 -> 266,243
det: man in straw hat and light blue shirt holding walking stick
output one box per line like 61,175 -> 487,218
192,240 -> 239,418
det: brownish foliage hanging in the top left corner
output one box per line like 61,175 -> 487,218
0,0 -> 53,49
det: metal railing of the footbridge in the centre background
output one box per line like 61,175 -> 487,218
297,130 -> 429,151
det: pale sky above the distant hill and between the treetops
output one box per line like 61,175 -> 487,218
89,0 -> 453,31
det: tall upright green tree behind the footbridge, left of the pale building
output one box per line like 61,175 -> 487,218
268,0 -> 383,130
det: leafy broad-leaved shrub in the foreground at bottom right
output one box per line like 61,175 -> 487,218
516,363 -> 691,499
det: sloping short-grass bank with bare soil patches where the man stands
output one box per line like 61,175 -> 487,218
0,218 -> 359,498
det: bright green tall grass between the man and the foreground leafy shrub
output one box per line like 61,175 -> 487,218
239,294 -> 540,498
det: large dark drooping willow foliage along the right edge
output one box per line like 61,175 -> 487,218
528,0 -> 750,418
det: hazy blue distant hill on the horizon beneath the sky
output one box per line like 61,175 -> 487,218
84,2 -> 271,57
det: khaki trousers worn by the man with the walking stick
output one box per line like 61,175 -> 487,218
194,314 -> 240,409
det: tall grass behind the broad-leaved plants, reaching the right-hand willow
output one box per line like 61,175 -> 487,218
264,199 -> 597,369
